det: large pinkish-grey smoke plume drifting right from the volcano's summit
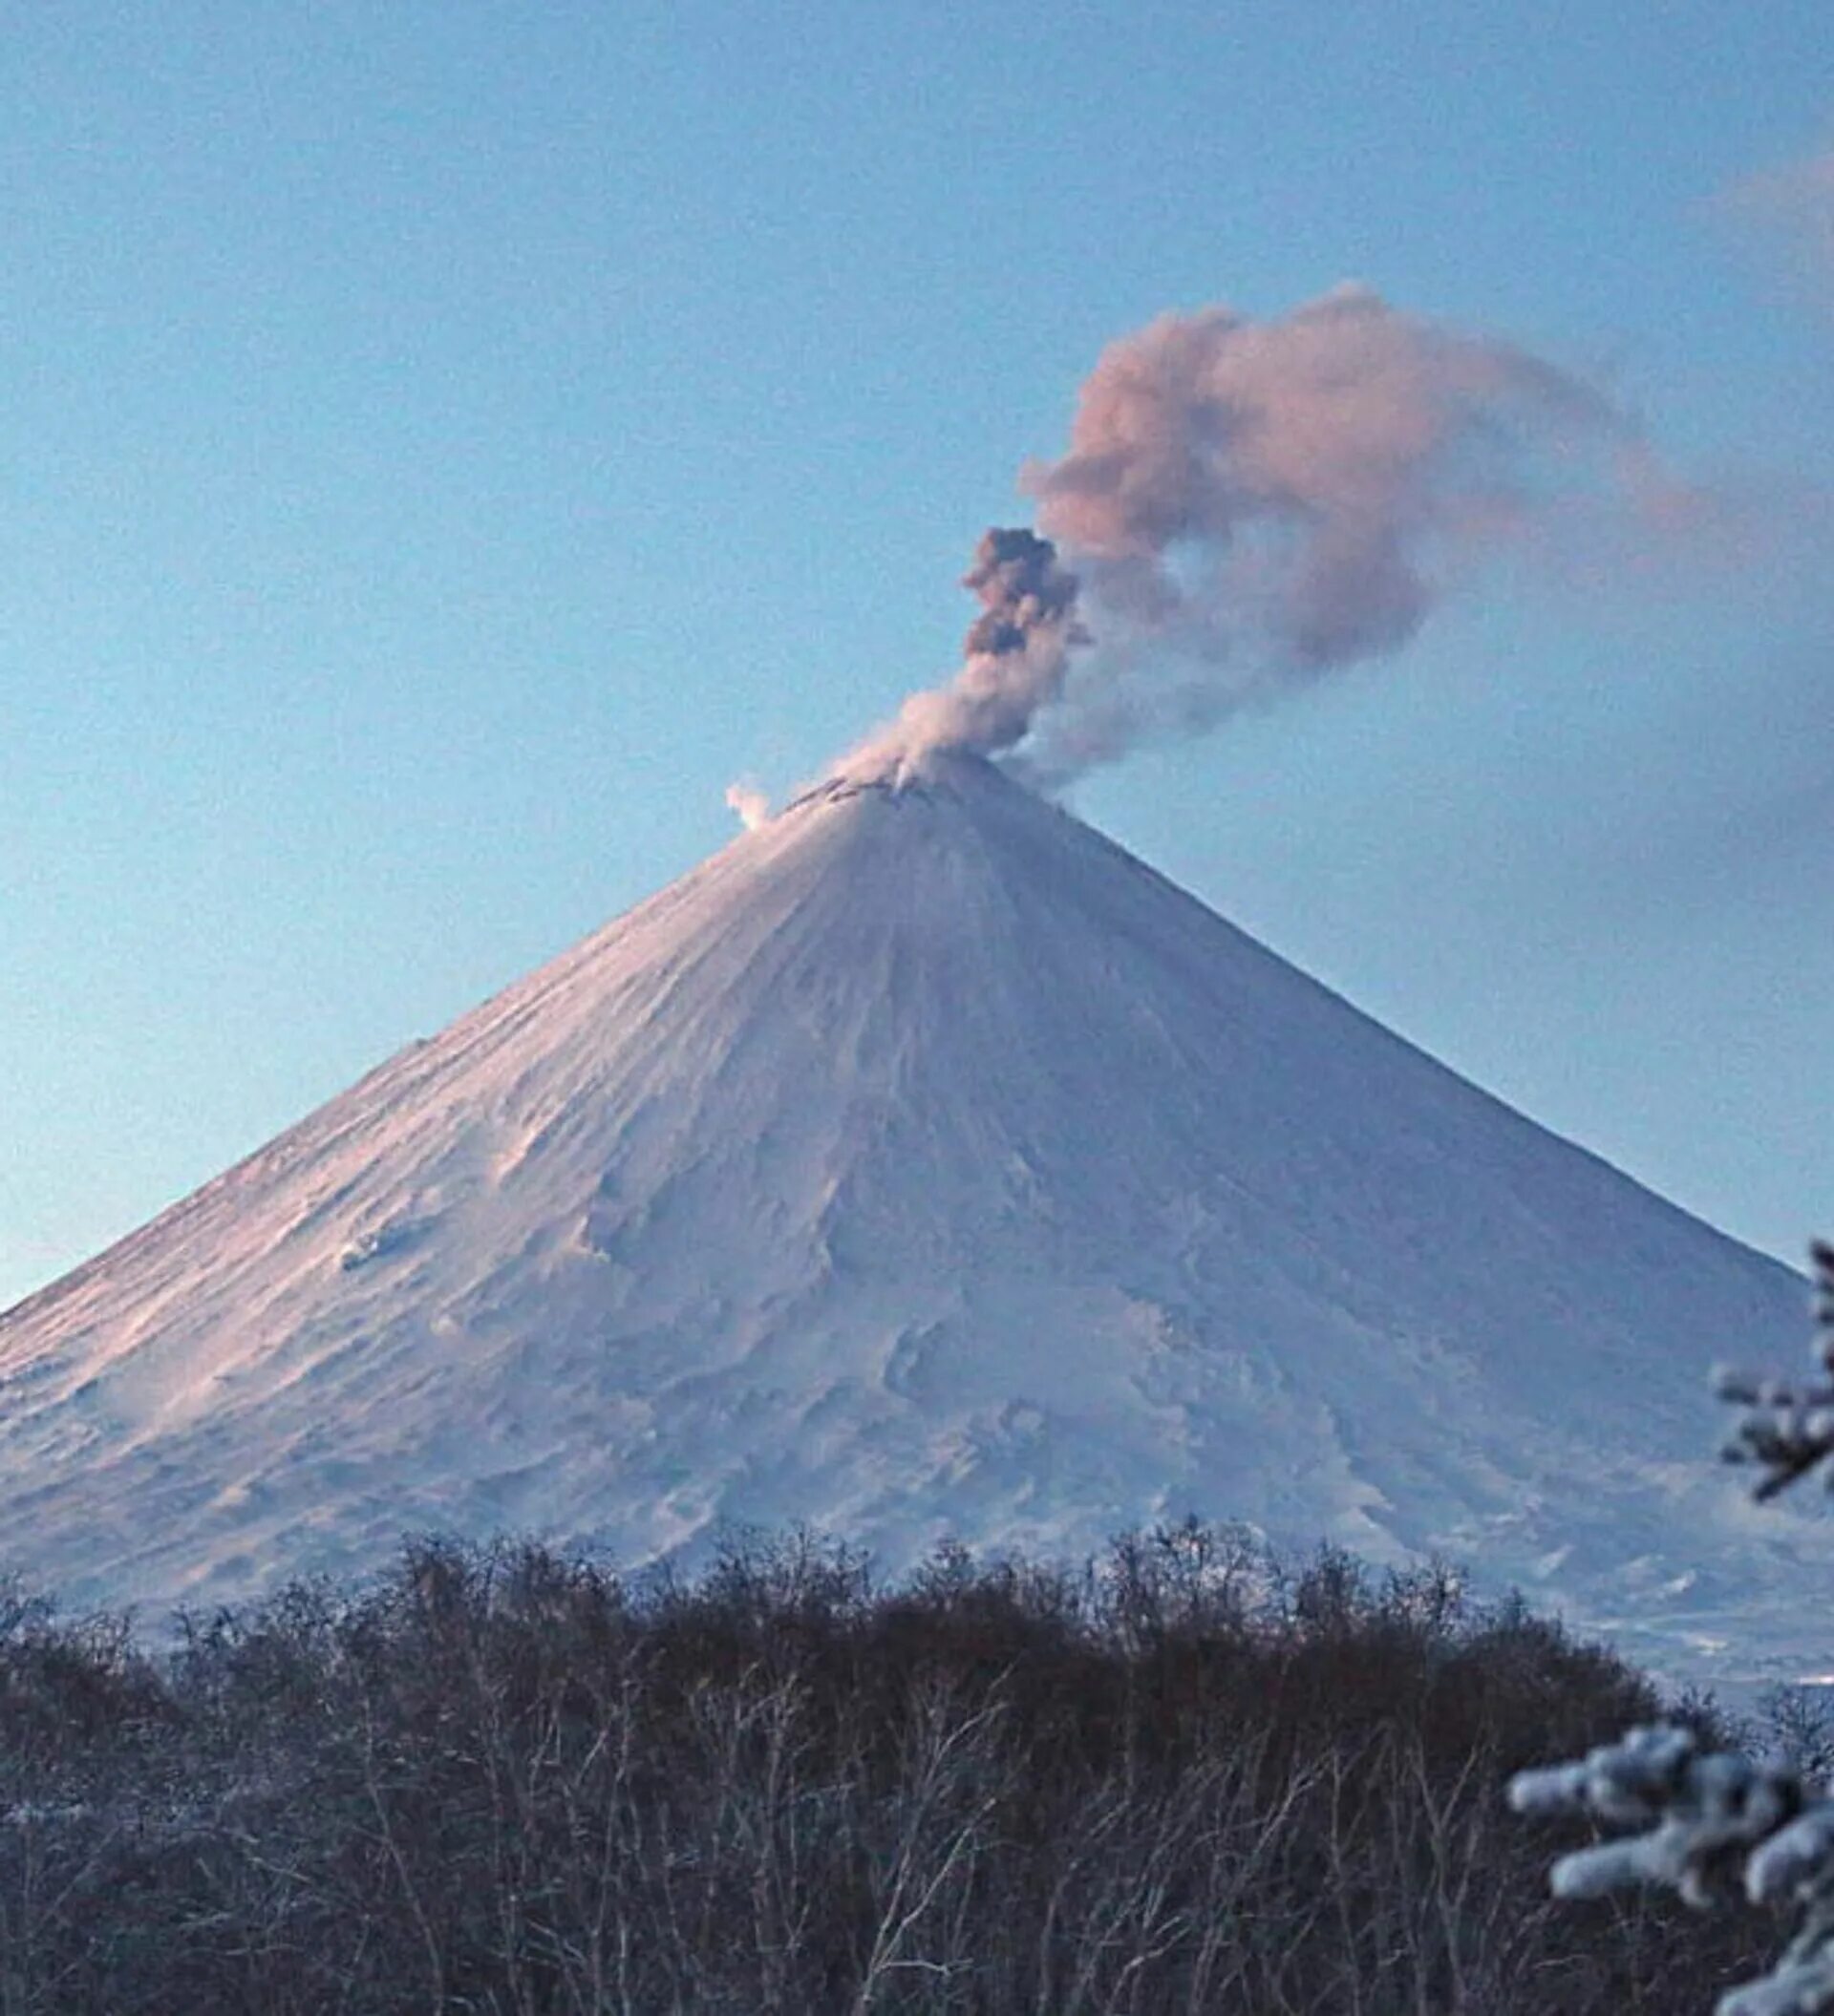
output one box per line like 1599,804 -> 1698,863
841,286 -> 1681,784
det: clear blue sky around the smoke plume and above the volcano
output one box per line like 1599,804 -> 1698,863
0,0 -> 1834,1303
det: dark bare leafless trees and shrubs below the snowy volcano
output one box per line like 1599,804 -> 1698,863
0,1526 -> 1781,2016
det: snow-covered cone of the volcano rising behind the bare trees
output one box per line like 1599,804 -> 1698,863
0,758 -> 1830,1667
